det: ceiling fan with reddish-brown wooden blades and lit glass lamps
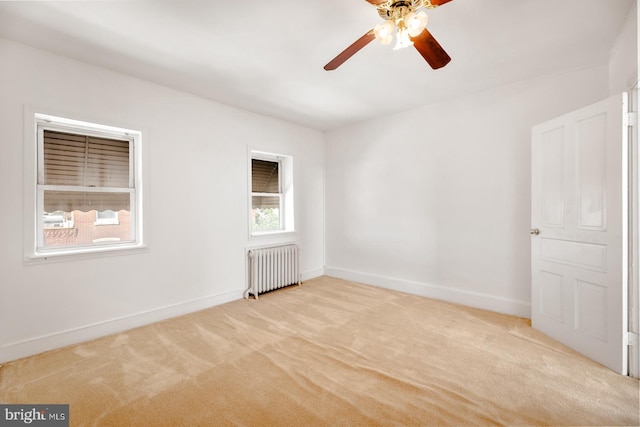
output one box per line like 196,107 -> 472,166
324,0 -> 451,71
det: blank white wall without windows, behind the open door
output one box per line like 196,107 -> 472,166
326,65 -> 609,317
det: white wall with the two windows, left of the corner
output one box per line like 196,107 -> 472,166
0,39 -> 324,361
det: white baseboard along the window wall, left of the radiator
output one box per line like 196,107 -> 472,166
0,290 -> 243,363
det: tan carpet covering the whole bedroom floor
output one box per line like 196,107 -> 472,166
0,277 -> 640,426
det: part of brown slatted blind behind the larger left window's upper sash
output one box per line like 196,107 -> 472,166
42,130 -> 129,188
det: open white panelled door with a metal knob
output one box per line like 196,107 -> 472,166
531,94 -> 628,375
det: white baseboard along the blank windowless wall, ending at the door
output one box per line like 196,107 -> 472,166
324,267 -> 531,319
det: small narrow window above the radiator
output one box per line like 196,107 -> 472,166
249,151 -> 293,235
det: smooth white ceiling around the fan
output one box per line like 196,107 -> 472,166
0,0 -> 635,130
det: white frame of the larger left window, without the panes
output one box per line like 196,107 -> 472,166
25,110 -> 145,260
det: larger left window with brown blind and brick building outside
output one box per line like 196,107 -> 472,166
35,114 -> 141,254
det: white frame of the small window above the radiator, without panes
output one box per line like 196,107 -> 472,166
248,149 -> 295,237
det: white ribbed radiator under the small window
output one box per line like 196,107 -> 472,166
244,245 -> 300,299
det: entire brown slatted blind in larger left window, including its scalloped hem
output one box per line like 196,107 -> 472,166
41,130 -> 130,212
